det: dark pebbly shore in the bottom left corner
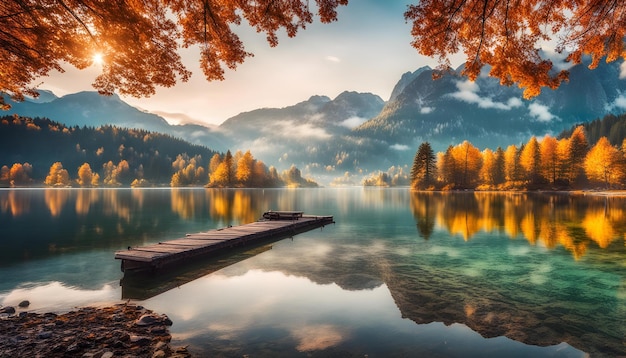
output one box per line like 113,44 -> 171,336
0,304 -> 190,358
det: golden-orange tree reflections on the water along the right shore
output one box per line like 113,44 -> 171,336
411,192 -> 626,259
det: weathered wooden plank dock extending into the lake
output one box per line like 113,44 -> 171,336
115,211 -> 335,272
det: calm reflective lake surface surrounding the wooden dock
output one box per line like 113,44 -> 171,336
0,187 -> 626,357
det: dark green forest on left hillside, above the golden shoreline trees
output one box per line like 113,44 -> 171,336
0,116 -> 216,186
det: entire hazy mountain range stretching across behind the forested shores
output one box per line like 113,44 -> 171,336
7,62 -> 626,184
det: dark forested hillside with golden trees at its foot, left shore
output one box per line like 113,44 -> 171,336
0,115 -> 317,187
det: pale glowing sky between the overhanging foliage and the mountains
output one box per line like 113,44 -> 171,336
40,0 -> 436,124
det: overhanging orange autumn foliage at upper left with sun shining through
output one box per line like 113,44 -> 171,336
0,0 -> 348,108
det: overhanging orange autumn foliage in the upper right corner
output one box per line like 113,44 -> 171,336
404,0 -> 626,98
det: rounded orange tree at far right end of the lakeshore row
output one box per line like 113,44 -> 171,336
584,137 -> 624,189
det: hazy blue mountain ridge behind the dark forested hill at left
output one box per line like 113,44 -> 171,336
1,91 -> 227,151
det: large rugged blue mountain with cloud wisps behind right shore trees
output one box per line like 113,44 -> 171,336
354,62 -> 626,154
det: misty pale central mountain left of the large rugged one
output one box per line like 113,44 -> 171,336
220,91 -> 385,181
